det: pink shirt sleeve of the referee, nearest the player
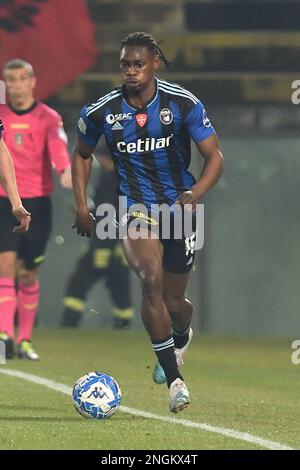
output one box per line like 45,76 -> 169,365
47,114 -> 71,174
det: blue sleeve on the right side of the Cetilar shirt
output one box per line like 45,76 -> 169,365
185,101 -> 215,142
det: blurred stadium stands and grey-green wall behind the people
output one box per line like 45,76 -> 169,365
0,0 -> 300,337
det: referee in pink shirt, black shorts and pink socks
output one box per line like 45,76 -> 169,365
0,59 -> 71,360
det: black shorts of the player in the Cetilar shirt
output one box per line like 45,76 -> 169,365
118,207 -> 197,274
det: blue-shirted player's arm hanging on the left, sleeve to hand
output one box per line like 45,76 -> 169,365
72,107 -> 101,237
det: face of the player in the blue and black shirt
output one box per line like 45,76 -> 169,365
120,46 -> 159,93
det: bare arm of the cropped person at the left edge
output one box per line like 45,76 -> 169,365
0,119 -> 31,233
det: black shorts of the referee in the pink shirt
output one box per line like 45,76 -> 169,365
0,196 -> 52,269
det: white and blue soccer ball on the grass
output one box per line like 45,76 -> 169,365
73,372 -> 121,419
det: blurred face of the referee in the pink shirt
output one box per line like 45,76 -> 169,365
4,67 -> 36,105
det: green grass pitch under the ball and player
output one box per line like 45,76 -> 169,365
0,329 -> 300,450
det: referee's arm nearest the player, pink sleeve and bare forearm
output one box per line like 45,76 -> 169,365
47,115 -> 72,189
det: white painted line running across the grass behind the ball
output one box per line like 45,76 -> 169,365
0,368 -> 294,450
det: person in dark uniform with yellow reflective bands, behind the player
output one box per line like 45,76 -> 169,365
62,150 -> 134,329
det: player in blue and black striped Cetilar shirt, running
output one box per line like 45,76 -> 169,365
72,32 -> 223,413
